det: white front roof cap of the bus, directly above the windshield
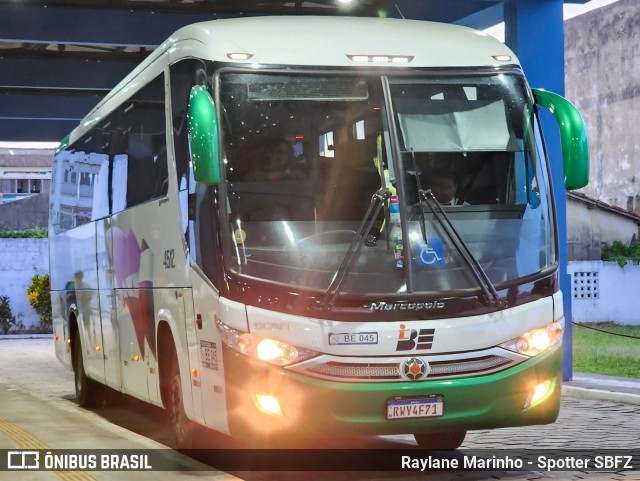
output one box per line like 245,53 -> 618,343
169,16 -> 518,67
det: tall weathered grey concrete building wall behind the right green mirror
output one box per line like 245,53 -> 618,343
564,0 -> 640,212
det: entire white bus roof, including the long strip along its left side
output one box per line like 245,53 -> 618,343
70,16 -> 519,142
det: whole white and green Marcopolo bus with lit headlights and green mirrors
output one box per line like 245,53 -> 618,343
50,17 -> 588,449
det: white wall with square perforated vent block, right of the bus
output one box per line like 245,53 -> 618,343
567,261 -> 640,325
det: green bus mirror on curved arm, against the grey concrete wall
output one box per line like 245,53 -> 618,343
533,89 -> 589,190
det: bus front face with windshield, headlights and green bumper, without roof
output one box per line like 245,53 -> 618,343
193,66 -> 584,448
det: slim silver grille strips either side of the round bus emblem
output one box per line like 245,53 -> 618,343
305,355 -> 519,381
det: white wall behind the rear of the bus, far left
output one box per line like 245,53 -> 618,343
0,239 -> 49,327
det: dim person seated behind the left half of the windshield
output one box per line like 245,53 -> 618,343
244,138 -> 306,181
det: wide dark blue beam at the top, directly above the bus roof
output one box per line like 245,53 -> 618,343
0,0 -> 386,47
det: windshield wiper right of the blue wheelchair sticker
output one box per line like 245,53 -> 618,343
418,189 -> 504,307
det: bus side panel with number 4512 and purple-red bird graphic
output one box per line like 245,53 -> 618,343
109,196 -> 191,404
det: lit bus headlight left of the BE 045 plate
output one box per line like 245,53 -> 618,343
216,319 -> 318,366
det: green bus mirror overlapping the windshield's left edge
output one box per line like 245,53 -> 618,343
189,85 -> 220,185
